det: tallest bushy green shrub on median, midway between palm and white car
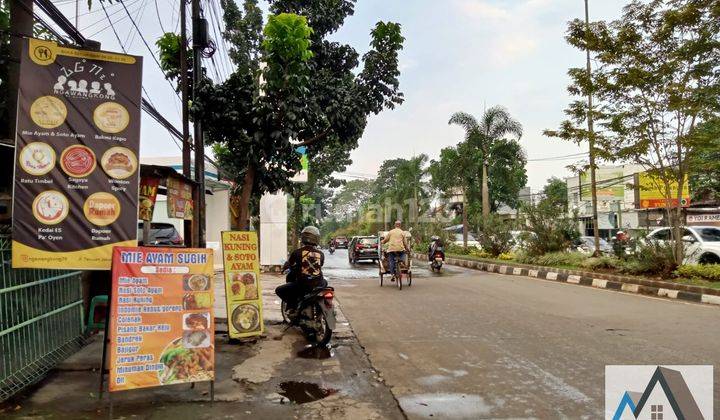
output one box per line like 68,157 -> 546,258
523,202 -> 580,256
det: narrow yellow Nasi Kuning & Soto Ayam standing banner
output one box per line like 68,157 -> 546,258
222,232 -> 264,338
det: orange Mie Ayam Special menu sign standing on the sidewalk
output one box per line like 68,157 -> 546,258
108,247 -> 215,391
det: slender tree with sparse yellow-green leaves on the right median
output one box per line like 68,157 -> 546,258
561,0 -> 720,263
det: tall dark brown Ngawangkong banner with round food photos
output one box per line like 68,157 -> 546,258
12,39 -> 142,270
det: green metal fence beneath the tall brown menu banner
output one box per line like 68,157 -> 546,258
0,235 -> 83,401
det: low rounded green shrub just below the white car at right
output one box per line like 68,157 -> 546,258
620,241 -> 677,278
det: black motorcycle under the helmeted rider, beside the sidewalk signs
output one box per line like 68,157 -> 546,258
280,276 -> 337,346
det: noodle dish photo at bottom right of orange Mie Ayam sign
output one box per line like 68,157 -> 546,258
158,337 -> 214,385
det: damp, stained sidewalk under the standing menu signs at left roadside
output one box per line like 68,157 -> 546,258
0,274 -> 403,419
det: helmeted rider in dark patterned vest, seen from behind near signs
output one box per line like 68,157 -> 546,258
275,226 -> 327,316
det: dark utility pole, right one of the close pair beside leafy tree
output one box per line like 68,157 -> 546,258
191,0 -> 207,248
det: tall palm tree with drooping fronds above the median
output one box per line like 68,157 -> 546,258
448,106 -> 522,216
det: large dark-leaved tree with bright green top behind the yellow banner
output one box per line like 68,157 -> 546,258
163,0 -> 404,227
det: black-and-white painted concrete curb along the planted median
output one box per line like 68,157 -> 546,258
412,252 -> 720,305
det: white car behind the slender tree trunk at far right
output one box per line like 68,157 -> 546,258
646,226 -> 720,264
